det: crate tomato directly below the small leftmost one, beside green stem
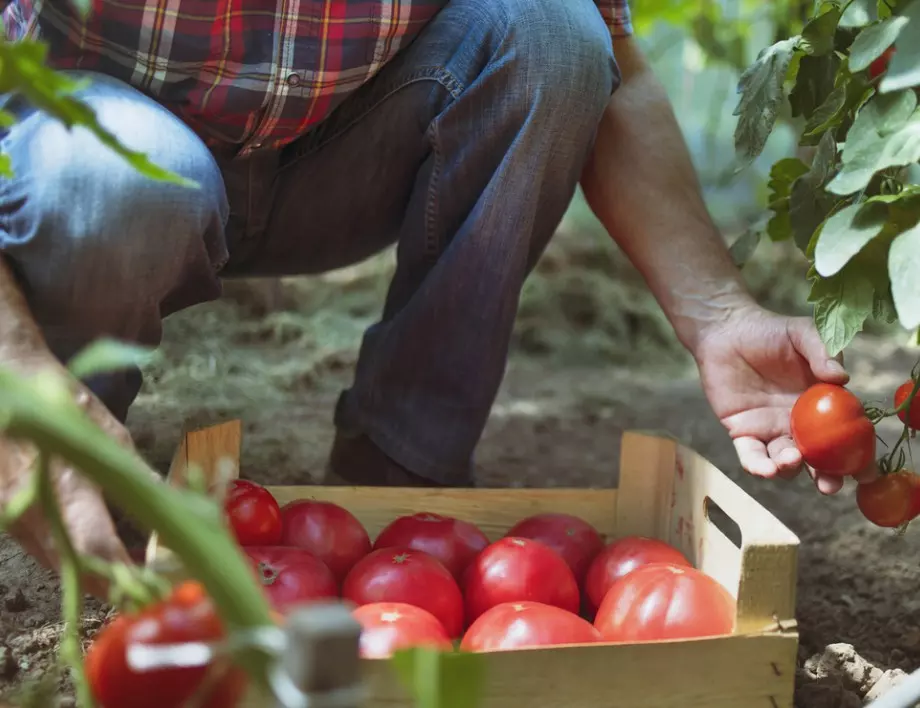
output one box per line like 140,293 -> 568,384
244,546 -> 339,613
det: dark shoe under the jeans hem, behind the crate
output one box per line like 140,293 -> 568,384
322,431 -> 445,487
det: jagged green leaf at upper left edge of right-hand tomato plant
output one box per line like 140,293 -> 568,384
732,37 -> 801,164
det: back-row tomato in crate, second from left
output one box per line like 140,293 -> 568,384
280,499 -> 371,583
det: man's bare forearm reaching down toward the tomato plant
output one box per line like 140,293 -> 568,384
582,38 -> 753,351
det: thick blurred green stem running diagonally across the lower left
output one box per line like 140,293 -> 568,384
0,368 -> 272,684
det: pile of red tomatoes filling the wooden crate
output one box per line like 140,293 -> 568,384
219,480 -> 735,658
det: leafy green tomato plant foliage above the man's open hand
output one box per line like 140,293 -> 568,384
735,0 -> 920,355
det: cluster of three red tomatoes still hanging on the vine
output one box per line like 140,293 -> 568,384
790,380 -> 920,528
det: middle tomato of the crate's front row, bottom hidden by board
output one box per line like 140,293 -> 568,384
460,602 -> 601,652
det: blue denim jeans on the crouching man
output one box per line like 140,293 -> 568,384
0,0 -> 620,484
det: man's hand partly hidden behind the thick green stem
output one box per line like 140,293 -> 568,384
0,355 -> 133,596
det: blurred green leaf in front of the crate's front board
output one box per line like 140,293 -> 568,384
390,647 -> 486,708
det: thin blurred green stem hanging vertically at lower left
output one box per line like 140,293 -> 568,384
36,450 -> 95,708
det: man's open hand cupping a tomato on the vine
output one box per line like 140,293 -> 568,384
694,306 -> 875,494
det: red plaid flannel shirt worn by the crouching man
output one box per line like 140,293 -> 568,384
2,0 -> 632,154
